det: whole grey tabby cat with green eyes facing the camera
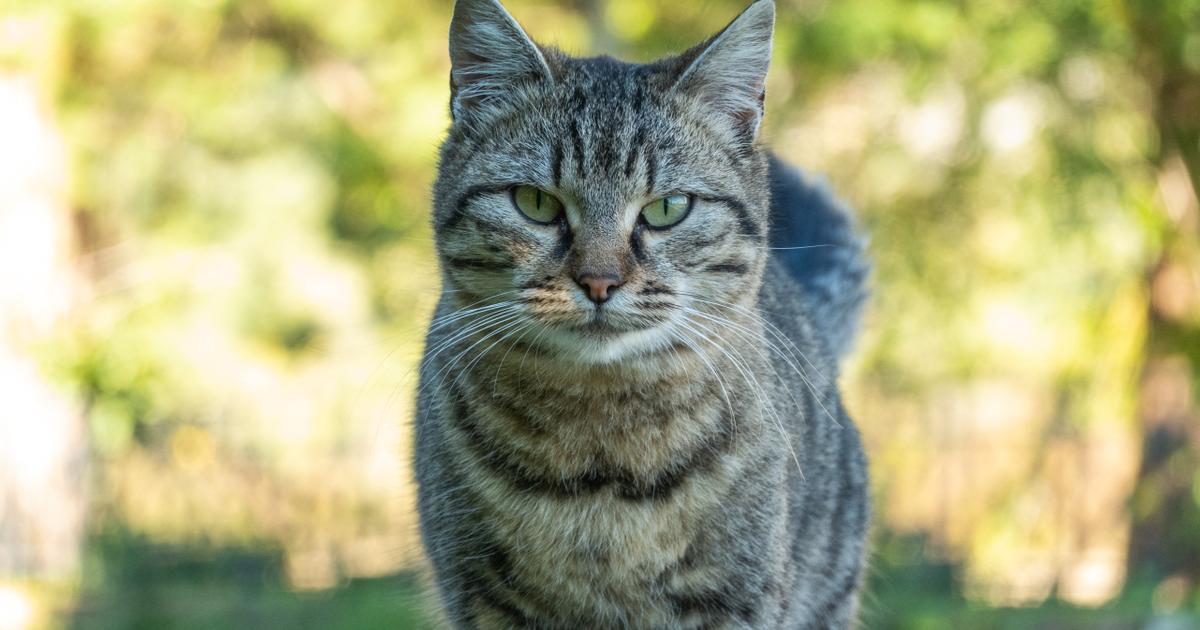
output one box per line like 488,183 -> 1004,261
415,0 -> 869,629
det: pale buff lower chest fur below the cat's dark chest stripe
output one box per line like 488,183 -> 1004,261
470,467 -> 733,628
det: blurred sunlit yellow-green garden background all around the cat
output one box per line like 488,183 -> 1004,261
0,0 -> 1200,630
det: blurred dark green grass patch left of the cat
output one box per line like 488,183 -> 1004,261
60,535 -> 433,630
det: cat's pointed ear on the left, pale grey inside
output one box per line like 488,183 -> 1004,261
450,0 -> 553,121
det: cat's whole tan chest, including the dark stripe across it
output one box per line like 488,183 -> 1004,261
454,374 -> 746,625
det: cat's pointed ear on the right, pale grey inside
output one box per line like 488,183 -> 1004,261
674,0 -> 775,142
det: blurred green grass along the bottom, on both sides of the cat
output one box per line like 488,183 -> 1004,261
51,534 -> 1200,630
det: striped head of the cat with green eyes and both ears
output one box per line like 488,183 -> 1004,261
434,0 -> 775,362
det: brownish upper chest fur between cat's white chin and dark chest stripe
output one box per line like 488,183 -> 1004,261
451,357 -> 739,470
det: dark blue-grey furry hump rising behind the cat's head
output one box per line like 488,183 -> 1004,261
769,155 -> 871,356
